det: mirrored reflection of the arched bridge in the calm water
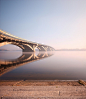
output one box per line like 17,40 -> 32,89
0,52 -> 53,76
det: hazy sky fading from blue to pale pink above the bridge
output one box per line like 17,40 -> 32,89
0,0 -> 86,49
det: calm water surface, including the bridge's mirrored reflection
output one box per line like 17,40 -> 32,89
0,51 -> 86,80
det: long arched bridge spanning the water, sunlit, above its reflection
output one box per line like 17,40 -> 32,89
0,30 -> 55,52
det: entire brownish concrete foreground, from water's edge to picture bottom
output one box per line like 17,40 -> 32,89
0,80 -> 86,99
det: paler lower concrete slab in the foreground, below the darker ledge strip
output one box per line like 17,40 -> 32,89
0,86 -> 86,99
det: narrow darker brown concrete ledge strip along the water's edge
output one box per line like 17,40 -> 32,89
0,80 -> 86,86
